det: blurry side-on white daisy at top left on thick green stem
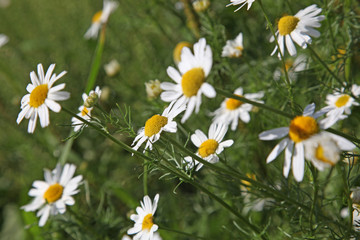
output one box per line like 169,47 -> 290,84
84,0 -> 119,39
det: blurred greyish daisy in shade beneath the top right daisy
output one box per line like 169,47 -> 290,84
274,54 -> 309,82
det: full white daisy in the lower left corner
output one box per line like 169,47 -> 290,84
21,164 -> 82,227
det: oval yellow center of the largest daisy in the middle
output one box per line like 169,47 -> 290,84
181,68 -> 205,97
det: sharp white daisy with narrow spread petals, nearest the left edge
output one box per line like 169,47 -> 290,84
16,63 -> 70,133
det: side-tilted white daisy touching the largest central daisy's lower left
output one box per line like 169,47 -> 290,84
132,102 -> 185,152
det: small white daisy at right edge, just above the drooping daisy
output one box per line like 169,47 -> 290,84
321,84 -> 360,128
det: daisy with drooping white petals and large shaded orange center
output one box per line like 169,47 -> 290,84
259,103 -> 324,182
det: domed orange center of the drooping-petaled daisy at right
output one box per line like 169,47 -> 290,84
289,116 -> 319,143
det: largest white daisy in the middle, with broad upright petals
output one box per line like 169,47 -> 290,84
160,38 -> 216,123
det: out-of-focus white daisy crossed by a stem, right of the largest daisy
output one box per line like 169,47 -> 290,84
213,87 -> 264,131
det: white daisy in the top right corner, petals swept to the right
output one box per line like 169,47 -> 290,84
270,4 -> 325,58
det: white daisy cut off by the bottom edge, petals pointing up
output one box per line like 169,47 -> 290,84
127,194 -> 159,240
